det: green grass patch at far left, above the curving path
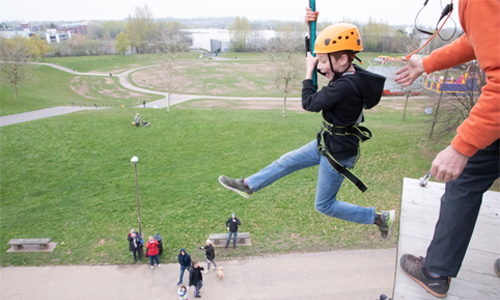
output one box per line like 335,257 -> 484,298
0,65 -> 162,116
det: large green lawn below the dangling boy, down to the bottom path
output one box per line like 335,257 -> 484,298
0,103 -> 449,267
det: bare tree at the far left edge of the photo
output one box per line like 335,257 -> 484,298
0,36 -> 30,100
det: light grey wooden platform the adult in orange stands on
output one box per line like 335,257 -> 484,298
392,177 -> 500,300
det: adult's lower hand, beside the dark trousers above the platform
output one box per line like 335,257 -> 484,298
431,145 -> 469,182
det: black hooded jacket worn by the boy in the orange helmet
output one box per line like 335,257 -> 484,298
302,65 -> 385,160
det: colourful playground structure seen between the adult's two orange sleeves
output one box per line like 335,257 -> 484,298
424,70 -> 479,94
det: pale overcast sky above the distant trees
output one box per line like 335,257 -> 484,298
0,0 -> 460,27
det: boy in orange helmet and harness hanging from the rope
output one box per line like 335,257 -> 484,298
219,9 -> 395,238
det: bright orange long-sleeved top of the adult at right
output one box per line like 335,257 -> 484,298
423,0 -> 500,156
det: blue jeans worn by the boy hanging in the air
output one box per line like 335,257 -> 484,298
245,140 -> 375,224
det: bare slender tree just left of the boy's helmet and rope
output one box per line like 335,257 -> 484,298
267,23 -> 306,117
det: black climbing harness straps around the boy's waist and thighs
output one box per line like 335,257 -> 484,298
318,119 -> 372,193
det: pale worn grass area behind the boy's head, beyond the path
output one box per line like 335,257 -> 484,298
129,52 -> 406,97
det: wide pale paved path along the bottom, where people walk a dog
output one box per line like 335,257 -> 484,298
0,249 -> 396,300
